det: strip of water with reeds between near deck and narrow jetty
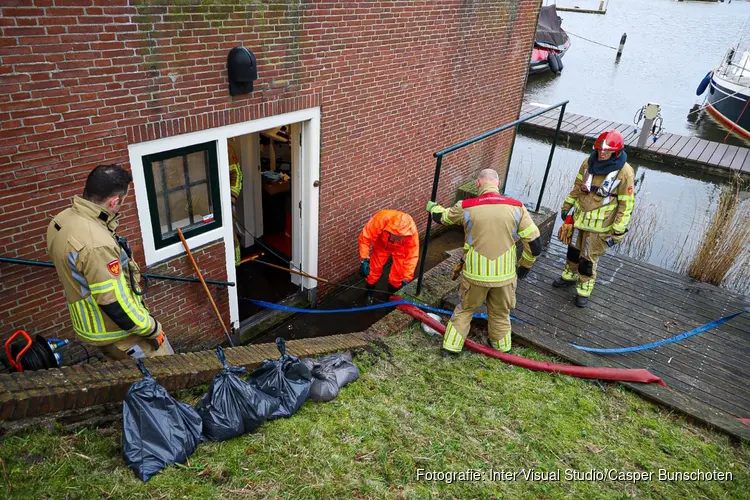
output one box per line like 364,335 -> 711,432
506,134 -> 750,295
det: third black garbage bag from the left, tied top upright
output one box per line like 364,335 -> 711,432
250,337 -> 312,420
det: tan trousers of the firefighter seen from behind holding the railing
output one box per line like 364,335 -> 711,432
443,276 -> 516,352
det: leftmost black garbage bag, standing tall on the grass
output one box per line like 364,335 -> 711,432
122,359 -> 203,481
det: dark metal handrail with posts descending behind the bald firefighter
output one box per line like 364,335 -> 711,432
417,101 -> 570,295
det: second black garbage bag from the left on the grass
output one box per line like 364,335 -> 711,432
196,346 -> 281,441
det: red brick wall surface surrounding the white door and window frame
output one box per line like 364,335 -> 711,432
0,0 -> 540,350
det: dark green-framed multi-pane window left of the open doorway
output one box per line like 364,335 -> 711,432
143,141 -> 221,250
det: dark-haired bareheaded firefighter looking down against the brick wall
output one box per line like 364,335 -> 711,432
47,165 -> 174,359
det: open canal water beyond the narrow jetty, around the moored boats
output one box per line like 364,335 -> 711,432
525,0 -> 750,146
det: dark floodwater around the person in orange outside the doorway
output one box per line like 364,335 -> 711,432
252,230 -> 464,344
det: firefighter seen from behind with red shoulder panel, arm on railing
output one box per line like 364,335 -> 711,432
427,169 -> 542,355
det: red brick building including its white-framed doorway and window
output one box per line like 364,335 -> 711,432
0,0 -> 540,358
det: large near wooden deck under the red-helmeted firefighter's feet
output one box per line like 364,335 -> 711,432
444,239 -> 750,442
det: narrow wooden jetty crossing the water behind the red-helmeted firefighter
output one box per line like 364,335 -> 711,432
520,104 -> 750,175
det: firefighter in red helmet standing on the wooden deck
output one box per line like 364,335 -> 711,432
552,130 -> 635,307
